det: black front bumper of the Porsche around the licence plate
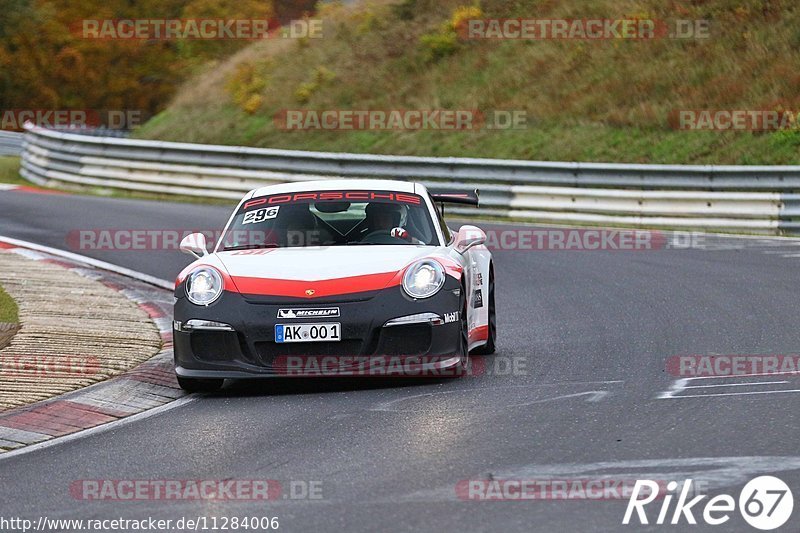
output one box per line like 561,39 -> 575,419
173,278 -> 461,379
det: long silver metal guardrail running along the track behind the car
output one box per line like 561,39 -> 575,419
21,125 -> 800,234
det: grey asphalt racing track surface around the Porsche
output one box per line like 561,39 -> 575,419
0,192 -> 800,532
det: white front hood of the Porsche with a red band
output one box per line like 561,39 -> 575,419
216,245 -> 437,299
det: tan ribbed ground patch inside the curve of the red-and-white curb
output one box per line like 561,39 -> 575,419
0,250 -> 162,411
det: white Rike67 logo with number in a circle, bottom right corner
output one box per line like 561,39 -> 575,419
622,476 -> 794,531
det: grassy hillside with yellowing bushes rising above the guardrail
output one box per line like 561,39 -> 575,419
137,0 -> 800,164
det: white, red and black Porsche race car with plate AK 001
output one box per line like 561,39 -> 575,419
173,179 -> 496,391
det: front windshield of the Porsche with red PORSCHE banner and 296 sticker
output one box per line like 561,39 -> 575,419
221,191 -> 439,251
